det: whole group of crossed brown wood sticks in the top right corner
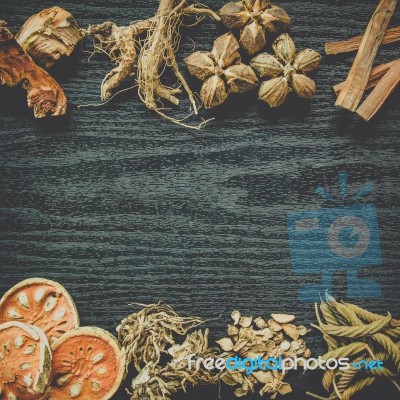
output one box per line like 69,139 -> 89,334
325,0 -> 400,121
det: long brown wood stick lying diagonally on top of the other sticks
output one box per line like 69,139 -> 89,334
336,0 -> 397,111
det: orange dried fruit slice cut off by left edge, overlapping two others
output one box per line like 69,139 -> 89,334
0,322 -> 51,400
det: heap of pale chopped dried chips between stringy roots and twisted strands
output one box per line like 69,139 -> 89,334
217,311 -> 311,399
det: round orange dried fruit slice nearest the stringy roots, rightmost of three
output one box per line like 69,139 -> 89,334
48,327 -> 125,400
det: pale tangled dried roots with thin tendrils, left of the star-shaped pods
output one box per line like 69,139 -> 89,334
86,0 -> 220,129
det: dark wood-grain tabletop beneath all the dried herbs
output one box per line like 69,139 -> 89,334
0,0 -> 400,400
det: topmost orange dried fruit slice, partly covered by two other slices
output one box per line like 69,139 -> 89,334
0,278 -> 79,344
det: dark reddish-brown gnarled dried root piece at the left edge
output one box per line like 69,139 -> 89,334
0,21 -> 67,118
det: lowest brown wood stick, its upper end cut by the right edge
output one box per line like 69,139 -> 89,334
357,60 -> 400,121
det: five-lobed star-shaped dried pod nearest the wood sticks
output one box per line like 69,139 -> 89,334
251,33 -> 321,108
